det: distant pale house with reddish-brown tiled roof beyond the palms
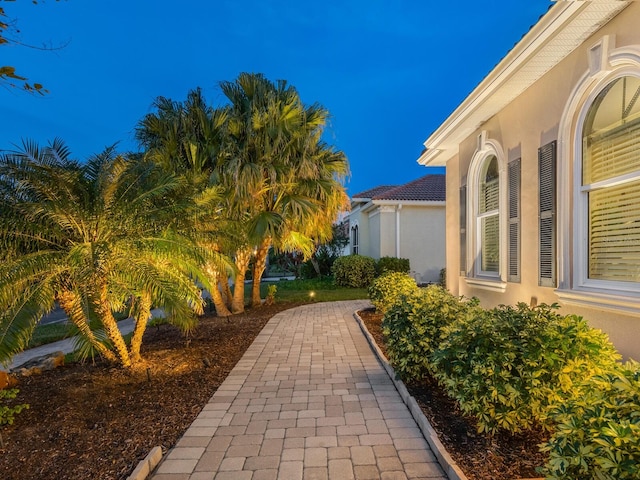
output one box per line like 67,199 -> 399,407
349,175 -> 446,283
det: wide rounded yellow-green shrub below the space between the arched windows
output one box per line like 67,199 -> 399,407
433,303 -> 619,434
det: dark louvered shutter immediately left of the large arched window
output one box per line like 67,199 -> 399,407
538,141 -> 557,287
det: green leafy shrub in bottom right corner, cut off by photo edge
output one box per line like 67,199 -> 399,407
542,363 -> 640,480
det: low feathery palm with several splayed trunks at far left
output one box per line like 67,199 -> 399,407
0,140 -> 215,367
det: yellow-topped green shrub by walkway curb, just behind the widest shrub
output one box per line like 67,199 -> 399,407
382,285 -> 477,380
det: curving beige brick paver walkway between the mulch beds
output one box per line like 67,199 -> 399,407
153,301 -> 447,480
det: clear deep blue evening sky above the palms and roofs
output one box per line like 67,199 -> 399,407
0,0 -> 551,194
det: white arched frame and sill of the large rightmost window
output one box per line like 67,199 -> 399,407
556,37 -> 640,313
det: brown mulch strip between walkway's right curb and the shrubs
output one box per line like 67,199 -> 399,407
358,309 -> 546,480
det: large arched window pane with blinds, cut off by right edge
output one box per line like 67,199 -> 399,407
577,76 -> 640,289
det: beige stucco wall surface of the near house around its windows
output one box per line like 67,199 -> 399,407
446,2 -> 640,360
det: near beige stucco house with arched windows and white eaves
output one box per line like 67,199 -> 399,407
418,0 -> 640,360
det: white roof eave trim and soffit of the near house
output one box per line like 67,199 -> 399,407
418,0 -> 633,165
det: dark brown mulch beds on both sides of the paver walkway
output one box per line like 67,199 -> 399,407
0,303 -> 544,480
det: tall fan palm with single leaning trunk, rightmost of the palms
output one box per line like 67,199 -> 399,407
220,73 -> 348,306
